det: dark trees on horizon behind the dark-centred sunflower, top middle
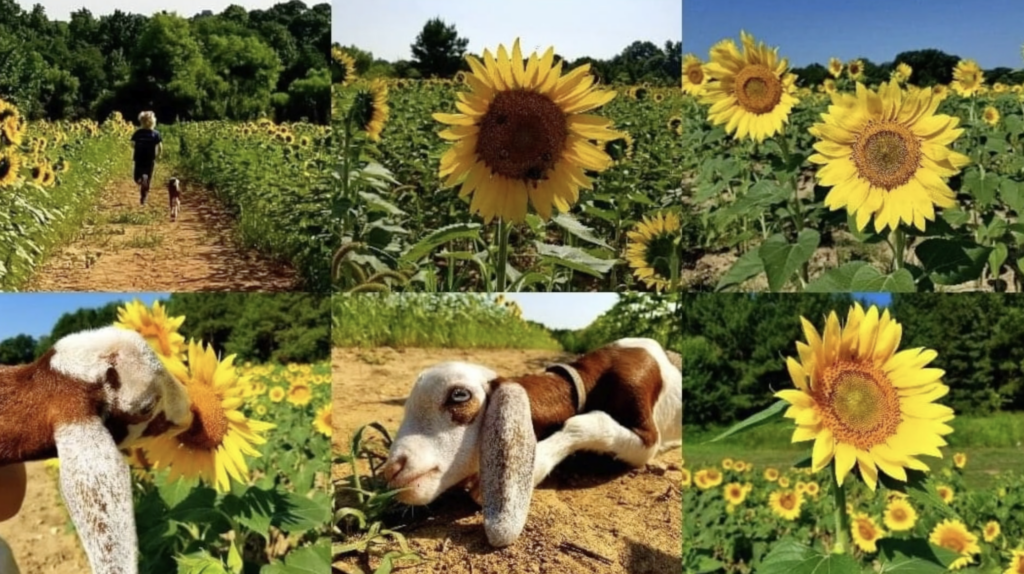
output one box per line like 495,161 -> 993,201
335,18 -> 683,87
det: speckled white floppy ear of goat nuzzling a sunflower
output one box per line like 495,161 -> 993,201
54,417 -> 138,574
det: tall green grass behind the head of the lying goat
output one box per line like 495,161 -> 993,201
332,294 -> 561,350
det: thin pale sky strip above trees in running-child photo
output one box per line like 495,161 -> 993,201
15,0 -> 286,21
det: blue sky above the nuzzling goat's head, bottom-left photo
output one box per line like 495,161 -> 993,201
0,293 -> 170,341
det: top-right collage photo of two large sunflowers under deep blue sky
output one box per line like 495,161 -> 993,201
682,0 -> 1024,293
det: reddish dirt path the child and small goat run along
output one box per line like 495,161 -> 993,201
25,177 -> 296,292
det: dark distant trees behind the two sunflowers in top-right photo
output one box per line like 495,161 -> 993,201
792,49 -> 1024,88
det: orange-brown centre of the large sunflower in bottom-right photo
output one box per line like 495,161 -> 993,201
818,362 -> 902,450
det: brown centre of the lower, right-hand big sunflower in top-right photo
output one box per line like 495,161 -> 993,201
851,121 -> 921,191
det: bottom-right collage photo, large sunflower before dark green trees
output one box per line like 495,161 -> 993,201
681,294 -> 1024,573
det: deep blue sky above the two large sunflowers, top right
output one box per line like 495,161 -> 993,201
683,0 -> 1024,69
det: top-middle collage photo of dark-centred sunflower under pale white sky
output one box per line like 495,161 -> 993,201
332,0 -> 684,293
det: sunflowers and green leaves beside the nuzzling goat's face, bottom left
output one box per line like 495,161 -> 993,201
46,301 -> 332,574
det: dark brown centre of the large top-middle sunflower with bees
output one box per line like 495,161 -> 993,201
476,90 -> 569,185
